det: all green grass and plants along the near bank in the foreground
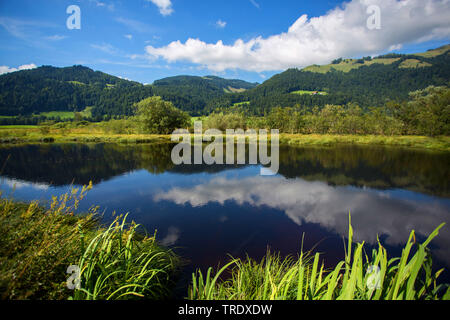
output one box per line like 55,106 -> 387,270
0,185 -> 450,300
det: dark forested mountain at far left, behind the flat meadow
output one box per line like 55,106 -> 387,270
0,66 -> 153,117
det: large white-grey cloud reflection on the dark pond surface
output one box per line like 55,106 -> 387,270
154,176 -> 450,264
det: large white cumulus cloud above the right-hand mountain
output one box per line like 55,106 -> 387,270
146,0 -> 450,72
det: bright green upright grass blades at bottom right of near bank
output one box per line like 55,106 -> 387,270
188,215 -> 450,300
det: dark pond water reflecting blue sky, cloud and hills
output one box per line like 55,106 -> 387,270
0,144 -> 450,294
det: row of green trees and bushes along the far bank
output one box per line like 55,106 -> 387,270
108,86 -> 450,136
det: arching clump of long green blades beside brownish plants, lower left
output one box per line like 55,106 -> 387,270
73,216 -> 179,300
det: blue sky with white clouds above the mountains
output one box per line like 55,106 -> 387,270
0,0 -> 450,83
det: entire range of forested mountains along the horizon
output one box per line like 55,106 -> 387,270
0,45 -> 450,121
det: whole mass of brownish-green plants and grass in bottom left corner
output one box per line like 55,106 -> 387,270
0,185 -> 179,300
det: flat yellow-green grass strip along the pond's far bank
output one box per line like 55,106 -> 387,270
0,124 -> 450,151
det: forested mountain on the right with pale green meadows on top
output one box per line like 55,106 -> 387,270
221,45 -> 450,114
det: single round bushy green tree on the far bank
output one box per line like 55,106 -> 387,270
134,96 -> 190,134
